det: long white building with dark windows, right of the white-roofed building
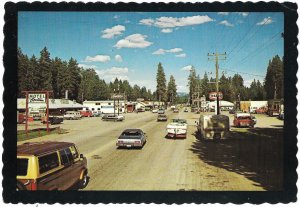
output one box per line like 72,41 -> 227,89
82,100 -> 126,114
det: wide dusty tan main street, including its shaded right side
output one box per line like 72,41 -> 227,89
18,109 -> 283,191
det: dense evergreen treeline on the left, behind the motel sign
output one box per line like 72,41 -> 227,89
18,47 -> 155,102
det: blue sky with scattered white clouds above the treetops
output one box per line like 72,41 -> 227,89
18,12 -> 284,92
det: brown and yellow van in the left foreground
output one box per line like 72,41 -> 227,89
16,142 -> 88,191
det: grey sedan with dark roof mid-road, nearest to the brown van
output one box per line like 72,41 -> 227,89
116,129 -> 147,148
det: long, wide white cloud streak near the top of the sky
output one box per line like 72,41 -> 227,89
140,15 -> 214,28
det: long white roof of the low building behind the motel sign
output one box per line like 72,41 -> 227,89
17,98 -> 84,109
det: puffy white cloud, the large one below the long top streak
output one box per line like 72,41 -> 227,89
114,34 -> 153,49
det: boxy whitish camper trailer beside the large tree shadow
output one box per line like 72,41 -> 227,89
197,115 -> 230,139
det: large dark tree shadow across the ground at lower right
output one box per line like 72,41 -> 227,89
190,128 -> 283,190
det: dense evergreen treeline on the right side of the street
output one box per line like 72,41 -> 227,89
188,55 -> 283,103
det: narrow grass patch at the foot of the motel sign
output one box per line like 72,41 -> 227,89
17,128 -> 68,142
